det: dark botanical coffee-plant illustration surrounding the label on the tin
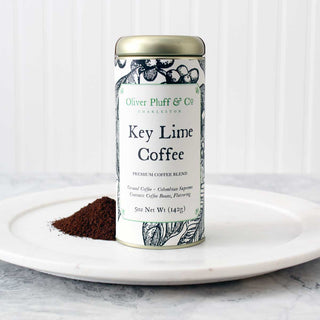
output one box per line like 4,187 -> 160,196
115,59 -> 205,246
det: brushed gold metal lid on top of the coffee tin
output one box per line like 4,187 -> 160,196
115,36 -> 205,57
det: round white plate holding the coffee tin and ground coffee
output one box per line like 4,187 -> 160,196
0,184 -> 320,285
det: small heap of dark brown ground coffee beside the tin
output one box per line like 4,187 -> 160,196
52,197 -> 116,240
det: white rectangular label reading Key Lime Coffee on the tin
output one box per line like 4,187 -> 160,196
118,83 -> 201,222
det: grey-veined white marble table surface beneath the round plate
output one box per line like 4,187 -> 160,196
0,174 -> 320,320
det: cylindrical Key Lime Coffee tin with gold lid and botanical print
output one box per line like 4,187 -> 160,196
115,36 -> 205,249
